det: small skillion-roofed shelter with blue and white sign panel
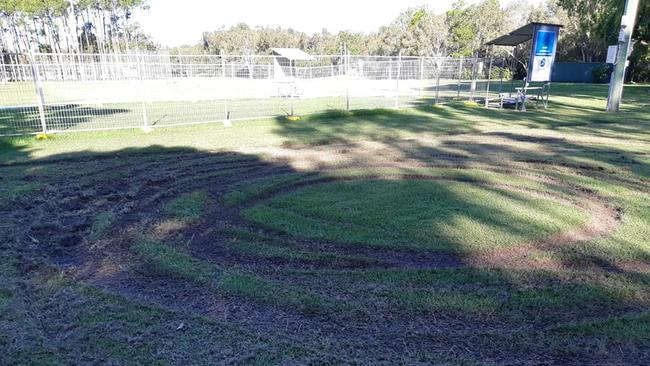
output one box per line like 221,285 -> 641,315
486,22 -> 563,110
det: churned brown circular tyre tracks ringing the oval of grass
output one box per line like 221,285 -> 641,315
5,148 -> 622,363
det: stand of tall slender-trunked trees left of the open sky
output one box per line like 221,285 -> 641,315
0,0 -> 153,53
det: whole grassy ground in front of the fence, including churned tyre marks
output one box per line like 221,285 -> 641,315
0,85 -> 650,365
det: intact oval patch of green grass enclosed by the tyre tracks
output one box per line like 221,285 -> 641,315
243,180 -> 587,253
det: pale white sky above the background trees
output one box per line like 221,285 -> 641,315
134,0 -> 539,47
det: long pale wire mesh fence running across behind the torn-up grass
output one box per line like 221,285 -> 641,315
0,54 -> 503,135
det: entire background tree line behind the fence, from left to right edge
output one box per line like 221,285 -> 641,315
0,0 -> 650,80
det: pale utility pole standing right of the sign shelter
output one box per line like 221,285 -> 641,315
607,0 -> 639,112
